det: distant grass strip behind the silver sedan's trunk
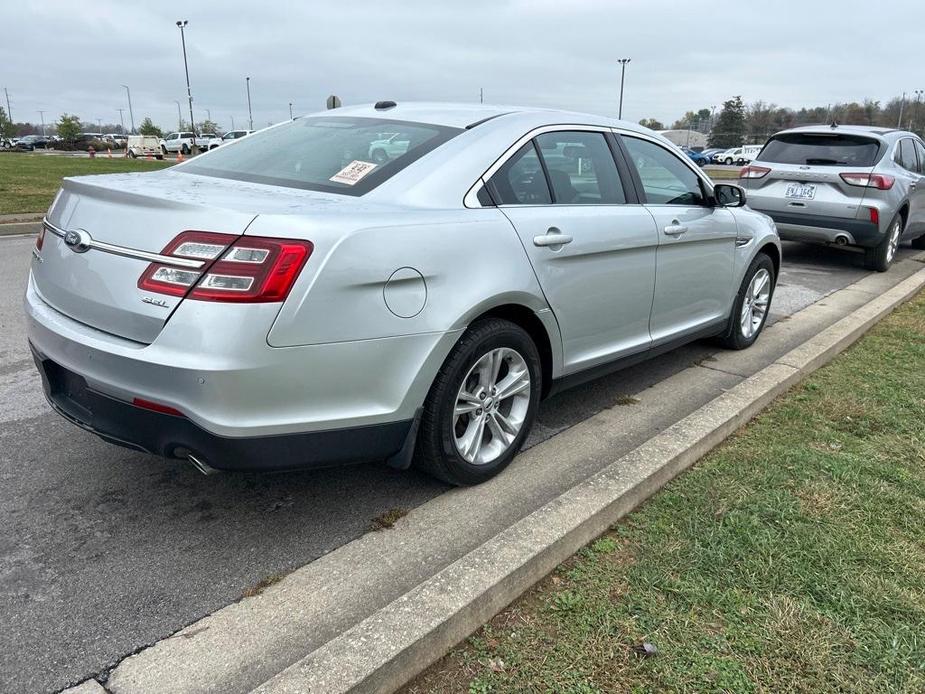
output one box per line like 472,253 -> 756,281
0,152 -> 172,214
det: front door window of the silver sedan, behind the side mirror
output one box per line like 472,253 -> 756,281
623,136 -> 706,205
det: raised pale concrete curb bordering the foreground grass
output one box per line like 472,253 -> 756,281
254,269 -> 925,694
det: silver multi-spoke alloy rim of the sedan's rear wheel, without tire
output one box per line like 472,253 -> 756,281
453,347 -> 532,465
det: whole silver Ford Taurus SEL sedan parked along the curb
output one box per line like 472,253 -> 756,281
25,102 -> 781,484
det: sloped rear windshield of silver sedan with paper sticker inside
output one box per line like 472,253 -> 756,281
177,116 -> 462,195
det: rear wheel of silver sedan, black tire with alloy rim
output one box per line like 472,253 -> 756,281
415,318 -> 542,485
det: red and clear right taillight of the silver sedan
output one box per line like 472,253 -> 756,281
138,231 -> 314,303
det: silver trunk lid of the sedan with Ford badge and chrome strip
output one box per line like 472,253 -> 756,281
32,171 -> 354,344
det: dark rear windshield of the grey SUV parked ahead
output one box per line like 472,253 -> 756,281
758,133 -> 880,166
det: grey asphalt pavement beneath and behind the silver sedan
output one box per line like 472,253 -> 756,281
0,237 -> 908,692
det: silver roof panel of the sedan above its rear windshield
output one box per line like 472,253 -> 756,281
310,101 -> 652,133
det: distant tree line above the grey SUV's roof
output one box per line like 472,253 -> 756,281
639,95 -> 925,147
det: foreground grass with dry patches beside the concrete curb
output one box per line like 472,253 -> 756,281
405,294 -> 925,694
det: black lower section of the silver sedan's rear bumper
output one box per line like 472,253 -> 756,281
33,346 -> 413,471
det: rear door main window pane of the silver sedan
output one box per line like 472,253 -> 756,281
536,131 -> 626,205
